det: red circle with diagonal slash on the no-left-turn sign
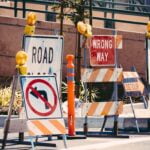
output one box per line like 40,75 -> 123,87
25,79 -> 57,116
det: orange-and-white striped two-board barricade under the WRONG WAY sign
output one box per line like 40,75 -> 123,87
81,68 -> 123,137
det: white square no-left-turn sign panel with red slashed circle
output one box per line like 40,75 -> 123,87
21,76 -> 62,119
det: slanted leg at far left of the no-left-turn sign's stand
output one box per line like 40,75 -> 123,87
2,70 -> 18,149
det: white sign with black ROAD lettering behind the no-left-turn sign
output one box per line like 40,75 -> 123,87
23,35 -> 63,89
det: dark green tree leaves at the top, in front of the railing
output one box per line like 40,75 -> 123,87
52,0 -> 89,26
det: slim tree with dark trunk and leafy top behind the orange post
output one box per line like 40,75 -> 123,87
53,0 -> 89,98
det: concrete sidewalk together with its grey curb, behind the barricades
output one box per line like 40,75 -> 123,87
0,103 -> 150,129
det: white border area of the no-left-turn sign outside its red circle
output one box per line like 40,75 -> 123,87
20,75 -> 63,120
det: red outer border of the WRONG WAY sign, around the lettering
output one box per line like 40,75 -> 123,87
89,35 -> 117,67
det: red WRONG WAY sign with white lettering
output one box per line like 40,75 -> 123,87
90,35 -> 116,66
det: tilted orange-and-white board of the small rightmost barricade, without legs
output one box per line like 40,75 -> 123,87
123,71 -> 144,96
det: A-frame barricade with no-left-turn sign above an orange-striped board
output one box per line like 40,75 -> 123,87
20,75 -> 67,147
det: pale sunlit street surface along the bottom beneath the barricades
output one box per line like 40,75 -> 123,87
0,128 -> 150,150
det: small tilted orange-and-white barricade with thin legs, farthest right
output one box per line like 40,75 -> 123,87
123,71 -> 147,132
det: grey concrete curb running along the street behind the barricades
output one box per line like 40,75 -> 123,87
0,115 -> 150,130
